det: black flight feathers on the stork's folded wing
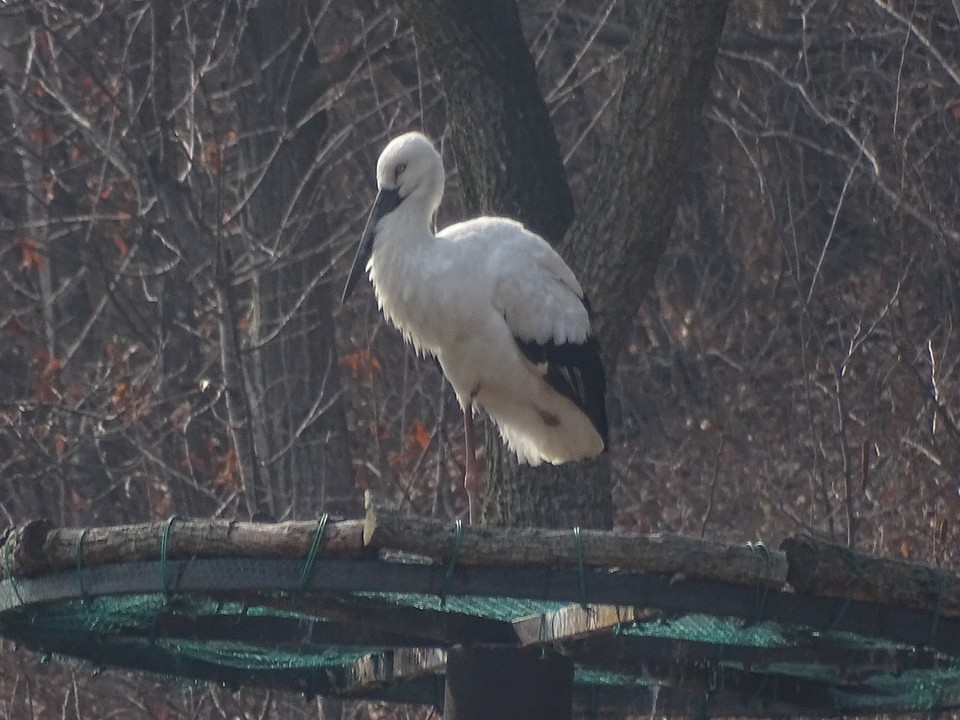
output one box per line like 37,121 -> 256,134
514,337 -> 609,446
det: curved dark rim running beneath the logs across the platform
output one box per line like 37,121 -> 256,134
9,559 -> 960,655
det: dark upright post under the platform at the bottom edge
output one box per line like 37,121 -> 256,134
443,647 -> 573,720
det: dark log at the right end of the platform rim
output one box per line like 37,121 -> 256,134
780,536 -> 960,617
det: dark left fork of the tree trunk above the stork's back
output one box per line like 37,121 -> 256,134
397,0 -> 573,244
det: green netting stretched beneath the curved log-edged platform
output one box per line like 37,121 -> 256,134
0,563 -> 960,715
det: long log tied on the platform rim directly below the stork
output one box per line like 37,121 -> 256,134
363,498 -> 787,588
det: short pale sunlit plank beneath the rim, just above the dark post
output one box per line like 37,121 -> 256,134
513,605 -> 651,646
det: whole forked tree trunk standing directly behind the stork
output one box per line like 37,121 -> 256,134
400,0 -> 727,528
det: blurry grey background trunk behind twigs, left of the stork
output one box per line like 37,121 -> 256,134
236,0 -> 360,518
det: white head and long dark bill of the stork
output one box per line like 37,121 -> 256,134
341,132 -> 444,302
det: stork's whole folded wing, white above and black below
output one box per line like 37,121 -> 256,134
494,230 -> 607,445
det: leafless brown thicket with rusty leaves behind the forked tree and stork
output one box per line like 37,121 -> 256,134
0,0 -> 960,720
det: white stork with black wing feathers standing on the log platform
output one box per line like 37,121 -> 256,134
343,132 -> 607,522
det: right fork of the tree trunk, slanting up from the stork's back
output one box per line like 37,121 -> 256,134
561,0 -> 727,366
